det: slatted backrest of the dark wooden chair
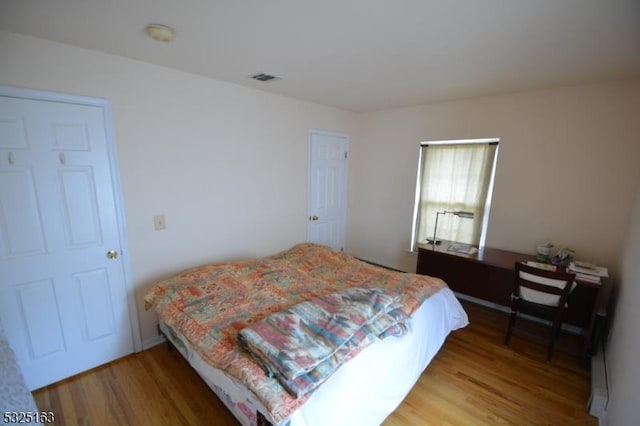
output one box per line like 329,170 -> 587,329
514,262 -> 576,306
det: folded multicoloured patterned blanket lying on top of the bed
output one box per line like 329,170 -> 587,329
238,287 -> 409,397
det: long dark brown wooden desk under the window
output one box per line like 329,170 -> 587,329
416,241 -> 605,356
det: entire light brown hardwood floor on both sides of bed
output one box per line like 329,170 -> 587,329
34,304 -> 597,426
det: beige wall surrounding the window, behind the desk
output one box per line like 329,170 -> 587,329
347,80 -> 640,278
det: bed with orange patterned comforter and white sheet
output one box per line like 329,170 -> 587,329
145,243 -> 468,426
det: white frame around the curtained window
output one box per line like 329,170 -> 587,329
410,137 -> 500,253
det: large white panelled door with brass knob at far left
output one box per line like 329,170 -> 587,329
0,90 -> 133,389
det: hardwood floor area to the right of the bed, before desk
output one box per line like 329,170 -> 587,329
385,303 -> 597,426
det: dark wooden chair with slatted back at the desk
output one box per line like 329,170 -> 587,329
504,262 -> 576,361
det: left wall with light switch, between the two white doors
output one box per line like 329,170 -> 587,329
0,32 -> 354,341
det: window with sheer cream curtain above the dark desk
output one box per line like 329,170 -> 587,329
411,139 -> 499,251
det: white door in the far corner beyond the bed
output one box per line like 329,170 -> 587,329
307,130 -> 349,250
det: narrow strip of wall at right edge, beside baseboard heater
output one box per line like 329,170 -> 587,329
606,185 -> 640,426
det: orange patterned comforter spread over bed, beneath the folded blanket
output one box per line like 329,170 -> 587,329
145,243 -> 445,423
